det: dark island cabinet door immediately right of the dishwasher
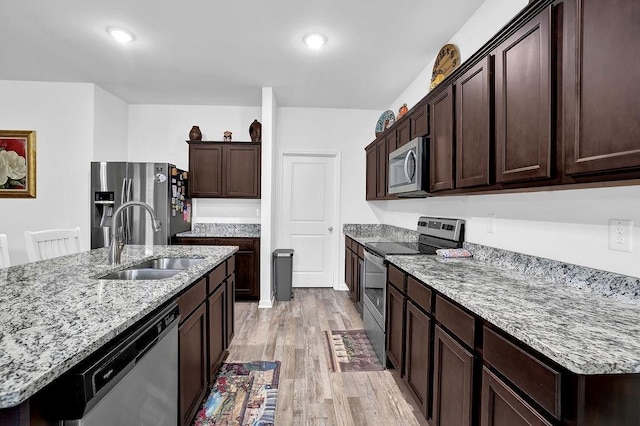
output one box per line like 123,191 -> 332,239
178,303 -> 208,425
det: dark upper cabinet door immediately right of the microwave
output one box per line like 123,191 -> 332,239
429,85 -> 454,192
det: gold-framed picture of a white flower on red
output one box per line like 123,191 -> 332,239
0,130 -> 36,198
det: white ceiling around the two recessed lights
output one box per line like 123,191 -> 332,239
0,0 -> 484,109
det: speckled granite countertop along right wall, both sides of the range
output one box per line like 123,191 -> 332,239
344,224 -> 640,375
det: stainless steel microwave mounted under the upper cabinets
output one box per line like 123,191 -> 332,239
387,137 -> 429,197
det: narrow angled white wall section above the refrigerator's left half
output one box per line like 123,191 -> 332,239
93,85 -> 129,161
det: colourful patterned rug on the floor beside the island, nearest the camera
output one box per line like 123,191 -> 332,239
193,361 -> 280,426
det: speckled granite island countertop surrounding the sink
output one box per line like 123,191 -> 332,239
0,246 -> 238,409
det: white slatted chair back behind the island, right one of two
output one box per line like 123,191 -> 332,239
24,228 -> 81,262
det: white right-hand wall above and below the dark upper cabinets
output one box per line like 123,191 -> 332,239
372,0 -> 640,277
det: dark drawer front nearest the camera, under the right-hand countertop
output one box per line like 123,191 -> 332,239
483,327 -> 560,419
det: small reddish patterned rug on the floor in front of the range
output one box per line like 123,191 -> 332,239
325,330 -> 384,372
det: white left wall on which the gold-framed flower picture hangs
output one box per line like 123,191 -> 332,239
0,81 -> 94,265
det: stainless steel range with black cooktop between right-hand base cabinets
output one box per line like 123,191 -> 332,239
362,216 -> 464,365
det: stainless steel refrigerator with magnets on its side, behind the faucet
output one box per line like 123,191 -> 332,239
91,162 -> 191,249
